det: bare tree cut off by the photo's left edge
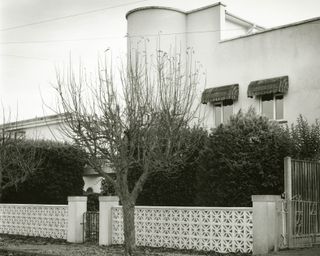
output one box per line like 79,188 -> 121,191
0,109 -> 42,202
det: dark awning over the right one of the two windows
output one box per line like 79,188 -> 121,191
247,76 -> 289,98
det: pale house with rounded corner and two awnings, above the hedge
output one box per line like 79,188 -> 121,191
126,3 -> 320,128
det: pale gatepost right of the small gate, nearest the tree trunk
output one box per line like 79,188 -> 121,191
99,196 -> 119,245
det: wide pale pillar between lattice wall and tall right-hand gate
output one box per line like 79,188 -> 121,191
252,195 -> 281,255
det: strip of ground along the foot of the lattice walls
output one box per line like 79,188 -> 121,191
0,235 -> 250,256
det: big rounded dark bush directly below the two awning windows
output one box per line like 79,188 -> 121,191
195,109 -> 290,206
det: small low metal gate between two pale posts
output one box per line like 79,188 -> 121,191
83,211 -> 99,242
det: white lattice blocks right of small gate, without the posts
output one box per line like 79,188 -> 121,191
112,207 -> 252,253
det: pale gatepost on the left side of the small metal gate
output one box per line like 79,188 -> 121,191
67,196 -> 87,243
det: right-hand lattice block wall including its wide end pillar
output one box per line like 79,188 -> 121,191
100,195 -> 283,255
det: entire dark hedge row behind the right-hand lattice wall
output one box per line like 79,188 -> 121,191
99,112 -> 320,206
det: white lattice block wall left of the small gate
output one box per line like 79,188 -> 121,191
0,204 -> 68,239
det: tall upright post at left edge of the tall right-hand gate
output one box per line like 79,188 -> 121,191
284,157 -> 294,248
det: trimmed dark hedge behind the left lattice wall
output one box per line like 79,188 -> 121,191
3,140 -> 86,204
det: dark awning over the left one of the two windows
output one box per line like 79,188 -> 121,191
201,84 -> 239,104
